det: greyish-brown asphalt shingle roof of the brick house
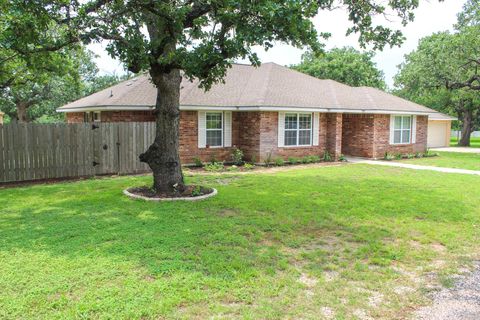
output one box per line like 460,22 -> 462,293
58,63 -> 454,114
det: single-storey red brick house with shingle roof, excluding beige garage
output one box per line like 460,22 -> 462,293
57,63 -> 454,163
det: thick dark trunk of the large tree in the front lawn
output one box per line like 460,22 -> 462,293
140,69 -> 184,194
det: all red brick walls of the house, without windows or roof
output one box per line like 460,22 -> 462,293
67,111 -> 428,164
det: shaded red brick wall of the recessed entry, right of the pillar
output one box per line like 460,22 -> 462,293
342,114 -> 375,158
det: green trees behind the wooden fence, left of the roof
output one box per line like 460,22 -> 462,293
0,47 -> 124,122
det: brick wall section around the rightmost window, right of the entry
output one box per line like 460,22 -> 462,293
373,114 -> 428,158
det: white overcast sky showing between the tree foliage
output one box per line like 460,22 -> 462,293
89,0 -> 465,87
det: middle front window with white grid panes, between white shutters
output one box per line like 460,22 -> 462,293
285,113 -> 312,146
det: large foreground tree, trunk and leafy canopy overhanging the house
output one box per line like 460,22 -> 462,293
7,0 -> 432,193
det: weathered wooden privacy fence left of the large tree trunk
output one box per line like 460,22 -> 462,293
0,122 -> 155,182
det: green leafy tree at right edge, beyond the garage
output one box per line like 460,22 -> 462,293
395,13 -> 480,146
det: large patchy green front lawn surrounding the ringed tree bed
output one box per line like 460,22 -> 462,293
0,164 -> 480,319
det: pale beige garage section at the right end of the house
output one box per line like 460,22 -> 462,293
427,113 -> 456,148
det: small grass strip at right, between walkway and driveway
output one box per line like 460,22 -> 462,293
402,152 -> 480,170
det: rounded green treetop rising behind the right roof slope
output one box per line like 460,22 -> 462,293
293,47 -> 386,90
